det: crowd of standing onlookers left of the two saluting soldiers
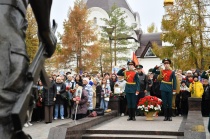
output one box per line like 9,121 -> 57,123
24,72 -> 117,127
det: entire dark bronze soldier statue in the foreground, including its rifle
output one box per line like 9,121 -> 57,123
0,0 -> 57,139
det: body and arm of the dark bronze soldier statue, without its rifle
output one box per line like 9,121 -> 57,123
0,0 -> 57,139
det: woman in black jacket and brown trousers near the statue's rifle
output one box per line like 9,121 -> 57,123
41,78 -> 57,124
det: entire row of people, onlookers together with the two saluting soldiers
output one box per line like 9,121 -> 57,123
24,59 -> 210,127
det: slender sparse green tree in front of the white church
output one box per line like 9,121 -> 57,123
101,4 -> 134,68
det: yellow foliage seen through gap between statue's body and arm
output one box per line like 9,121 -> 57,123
26,6 -> 39,62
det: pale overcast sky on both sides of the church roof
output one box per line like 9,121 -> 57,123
51,0 -> 164,34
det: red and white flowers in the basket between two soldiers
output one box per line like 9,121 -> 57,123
137,96 -> 162,113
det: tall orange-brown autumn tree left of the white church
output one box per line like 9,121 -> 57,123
57,0 -> 99,71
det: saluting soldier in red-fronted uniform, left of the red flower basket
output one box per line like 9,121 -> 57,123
117,60 -> 140,121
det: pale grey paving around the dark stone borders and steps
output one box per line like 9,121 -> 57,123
23,116 -> 210,139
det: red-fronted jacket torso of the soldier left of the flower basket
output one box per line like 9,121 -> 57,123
124,70 -> 140,93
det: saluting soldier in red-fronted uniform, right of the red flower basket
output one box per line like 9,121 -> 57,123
153,58 -> 176,121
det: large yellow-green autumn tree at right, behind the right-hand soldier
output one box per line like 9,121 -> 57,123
153,0 -> 209,70
